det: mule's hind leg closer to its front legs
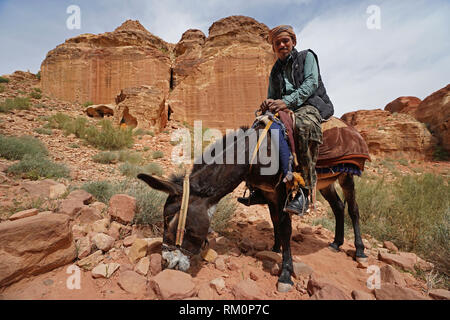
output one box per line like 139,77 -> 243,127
320,184 -> 345,251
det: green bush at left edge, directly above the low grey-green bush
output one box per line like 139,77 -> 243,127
0,135 -> 48,160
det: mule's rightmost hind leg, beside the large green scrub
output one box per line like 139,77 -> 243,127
339,174 -> 367,261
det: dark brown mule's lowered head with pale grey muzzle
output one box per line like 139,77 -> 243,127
138,173 -> 215,271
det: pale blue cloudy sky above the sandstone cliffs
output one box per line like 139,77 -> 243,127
0,0 -> 450,117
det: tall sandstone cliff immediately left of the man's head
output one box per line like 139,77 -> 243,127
168,16 -> 275,131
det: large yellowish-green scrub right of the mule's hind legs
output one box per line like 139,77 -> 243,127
356,173 -> 450,275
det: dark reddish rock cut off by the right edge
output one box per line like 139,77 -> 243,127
415,84 -> 450,152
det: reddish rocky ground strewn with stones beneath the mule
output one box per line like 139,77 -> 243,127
0,72 -> 450,300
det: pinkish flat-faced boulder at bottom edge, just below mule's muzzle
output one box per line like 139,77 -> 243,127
150,269 -> 197,300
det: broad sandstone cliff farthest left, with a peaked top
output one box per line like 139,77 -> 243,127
41,20 -> 173,103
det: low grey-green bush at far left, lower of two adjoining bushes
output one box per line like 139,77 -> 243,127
7,154 -> 70,180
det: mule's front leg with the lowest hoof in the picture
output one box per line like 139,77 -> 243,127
278,210 -> 294,292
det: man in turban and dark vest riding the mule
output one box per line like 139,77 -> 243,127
238,25 -> 334,215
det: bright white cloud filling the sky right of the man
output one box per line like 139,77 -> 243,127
297,1 -> 450,116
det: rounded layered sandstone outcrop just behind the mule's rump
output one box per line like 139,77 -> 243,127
341,109 -> 435,159
